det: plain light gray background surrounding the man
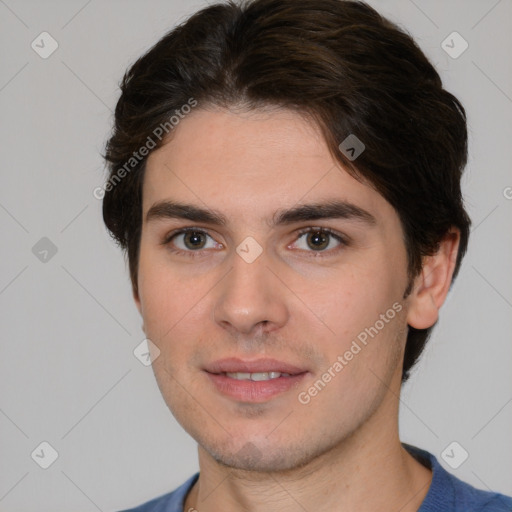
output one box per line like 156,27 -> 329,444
0,0 -> 512,512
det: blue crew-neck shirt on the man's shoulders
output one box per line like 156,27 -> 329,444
123,443 -> 512,512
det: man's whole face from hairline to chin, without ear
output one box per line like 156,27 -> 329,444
135,110 -> 408,471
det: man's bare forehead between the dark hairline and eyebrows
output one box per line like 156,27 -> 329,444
143,109 -> 394,224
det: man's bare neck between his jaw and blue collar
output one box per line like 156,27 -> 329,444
184,376 -> 432,512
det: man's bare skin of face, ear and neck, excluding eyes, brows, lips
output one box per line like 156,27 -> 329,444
134,108 -> 458,512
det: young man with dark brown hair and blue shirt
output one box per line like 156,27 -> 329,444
103,0 -> 512,512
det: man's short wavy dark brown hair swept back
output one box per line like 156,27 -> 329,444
103,0 -> 470,381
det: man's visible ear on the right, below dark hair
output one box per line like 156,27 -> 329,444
407,228 -> 460,329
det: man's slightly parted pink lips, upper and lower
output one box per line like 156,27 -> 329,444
205,358 -> 309,403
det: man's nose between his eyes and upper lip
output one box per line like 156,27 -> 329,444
214,247 -> 289,336
